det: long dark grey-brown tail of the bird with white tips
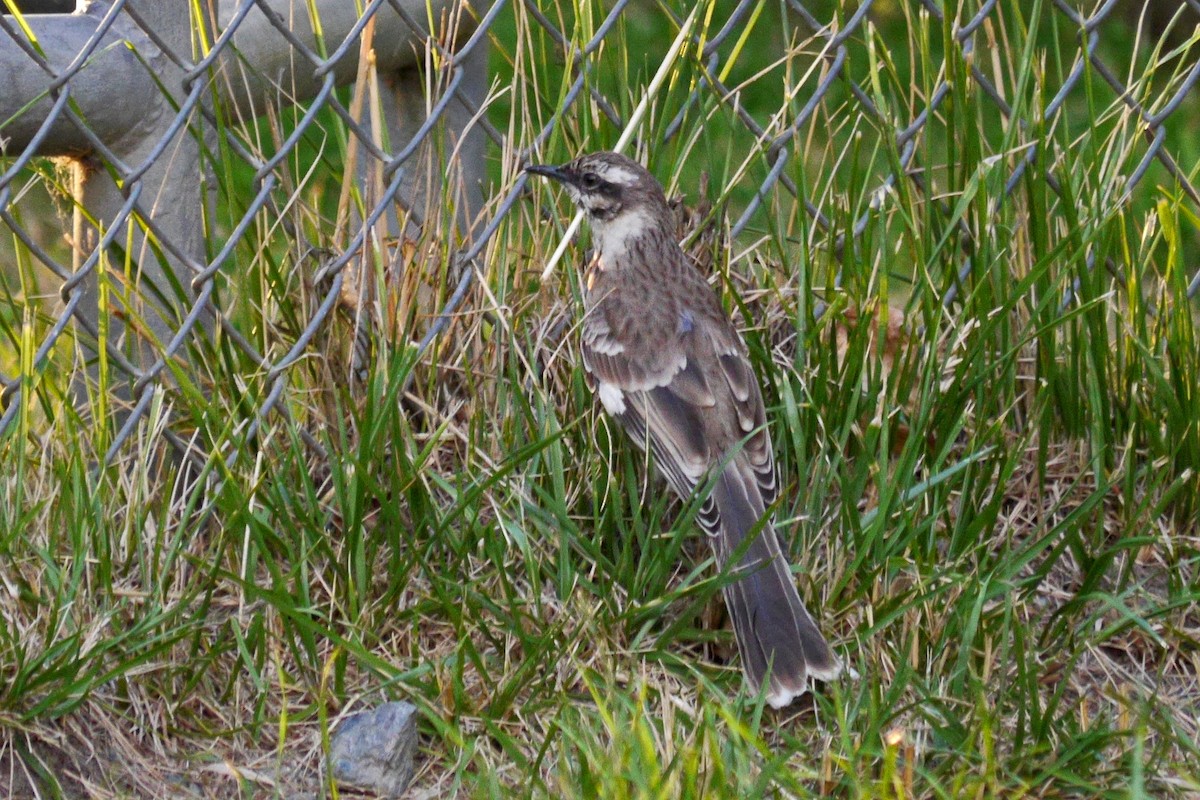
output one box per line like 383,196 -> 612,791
700,459 -> 841,709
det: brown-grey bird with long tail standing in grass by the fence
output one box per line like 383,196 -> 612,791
526,151 -> 841,709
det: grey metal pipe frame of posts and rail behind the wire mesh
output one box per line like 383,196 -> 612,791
0,0 -> 487,447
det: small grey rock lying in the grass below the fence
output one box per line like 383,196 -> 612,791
330,702 -> 416,798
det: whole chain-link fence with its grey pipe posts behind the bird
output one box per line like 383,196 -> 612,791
0,0 -> 1200,472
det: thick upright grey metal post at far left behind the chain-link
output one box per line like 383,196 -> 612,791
72,0 -> 208,383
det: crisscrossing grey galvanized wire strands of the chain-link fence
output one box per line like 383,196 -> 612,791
0,0 -> 1200,464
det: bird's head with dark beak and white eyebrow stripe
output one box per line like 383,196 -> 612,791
526,151 -> 672,252
